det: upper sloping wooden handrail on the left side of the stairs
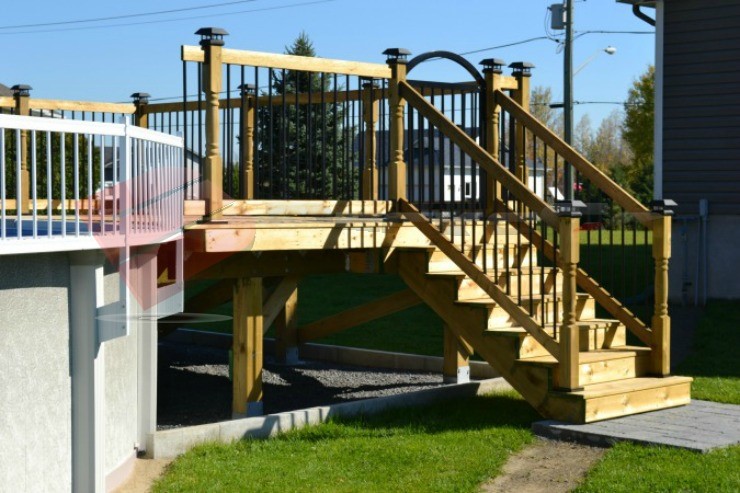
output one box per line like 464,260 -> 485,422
399,82 -> 558,227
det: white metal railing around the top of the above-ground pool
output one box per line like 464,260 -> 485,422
0,115 -> 183,253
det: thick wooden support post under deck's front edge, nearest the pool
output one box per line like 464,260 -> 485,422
232,277 -> 263,418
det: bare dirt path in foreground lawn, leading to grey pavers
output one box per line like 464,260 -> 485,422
481,440 -> 605,493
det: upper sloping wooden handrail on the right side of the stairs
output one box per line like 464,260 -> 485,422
494,90 -> 653,227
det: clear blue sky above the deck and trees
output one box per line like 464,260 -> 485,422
0,0 -> 655,126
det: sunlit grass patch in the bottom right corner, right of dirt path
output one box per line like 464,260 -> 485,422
576,443 -> 740,493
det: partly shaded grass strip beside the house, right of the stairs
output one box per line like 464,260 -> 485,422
676,301 -> 740,405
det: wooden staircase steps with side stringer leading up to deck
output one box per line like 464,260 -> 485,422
396,206 -> 691,423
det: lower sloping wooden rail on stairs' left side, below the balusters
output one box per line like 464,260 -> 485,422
398,199 -> 560,361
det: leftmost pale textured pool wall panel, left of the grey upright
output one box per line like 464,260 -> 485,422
0,253 -> 72,492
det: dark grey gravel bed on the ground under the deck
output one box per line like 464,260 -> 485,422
157,342 -> 444,430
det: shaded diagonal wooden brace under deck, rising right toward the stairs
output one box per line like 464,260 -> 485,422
298,289 -> 421,343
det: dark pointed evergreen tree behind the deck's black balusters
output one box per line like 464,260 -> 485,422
256,33 -> 358,199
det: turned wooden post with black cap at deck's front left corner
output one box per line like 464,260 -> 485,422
195,27 -> 228,221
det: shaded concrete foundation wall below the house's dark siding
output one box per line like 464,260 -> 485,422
669,215 -> 740,304
